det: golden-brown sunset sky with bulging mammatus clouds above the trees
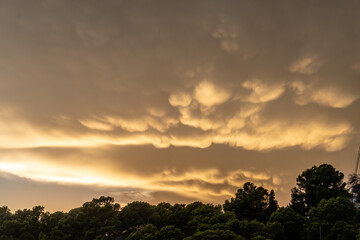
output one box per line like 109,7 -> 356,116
0,0 -> 360,211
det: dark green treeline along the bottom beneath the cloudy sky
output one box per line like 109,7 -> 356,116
0,164 -> 360,240
